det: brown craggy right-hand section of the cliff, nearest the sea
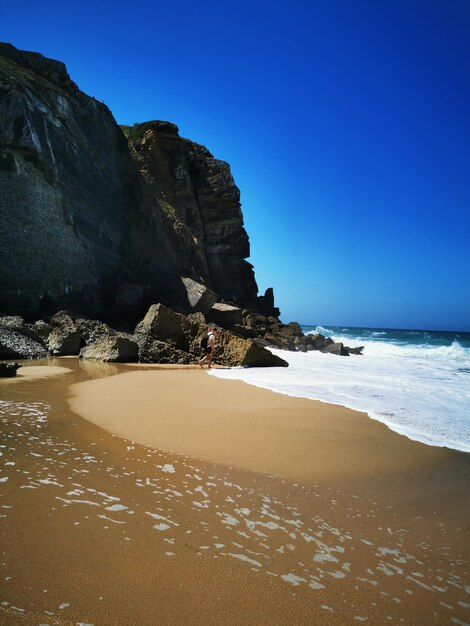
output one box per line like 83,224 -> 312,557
123,121 -> 258,306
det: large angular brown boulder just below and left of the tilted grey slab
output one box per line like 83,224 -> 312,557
135,304 -> 196,352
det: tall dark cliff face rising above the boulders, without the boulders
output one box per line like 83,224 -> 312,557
0,44 -> 275,318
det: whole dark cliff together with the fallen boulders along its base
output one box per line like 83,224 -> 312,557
0,43 -> 364,366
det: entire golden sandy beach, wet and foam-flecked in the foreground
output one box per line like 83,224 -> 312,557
0,359 -> 470,625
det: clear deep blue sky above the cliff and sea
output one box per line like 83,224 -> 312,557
0,0 -> 470,330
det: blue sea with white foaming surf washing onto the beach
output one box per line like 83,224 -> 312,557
212,326 -> 470,452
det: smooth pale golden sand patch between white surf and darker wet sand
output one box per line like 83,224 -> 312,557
68,366 -> 470,516
